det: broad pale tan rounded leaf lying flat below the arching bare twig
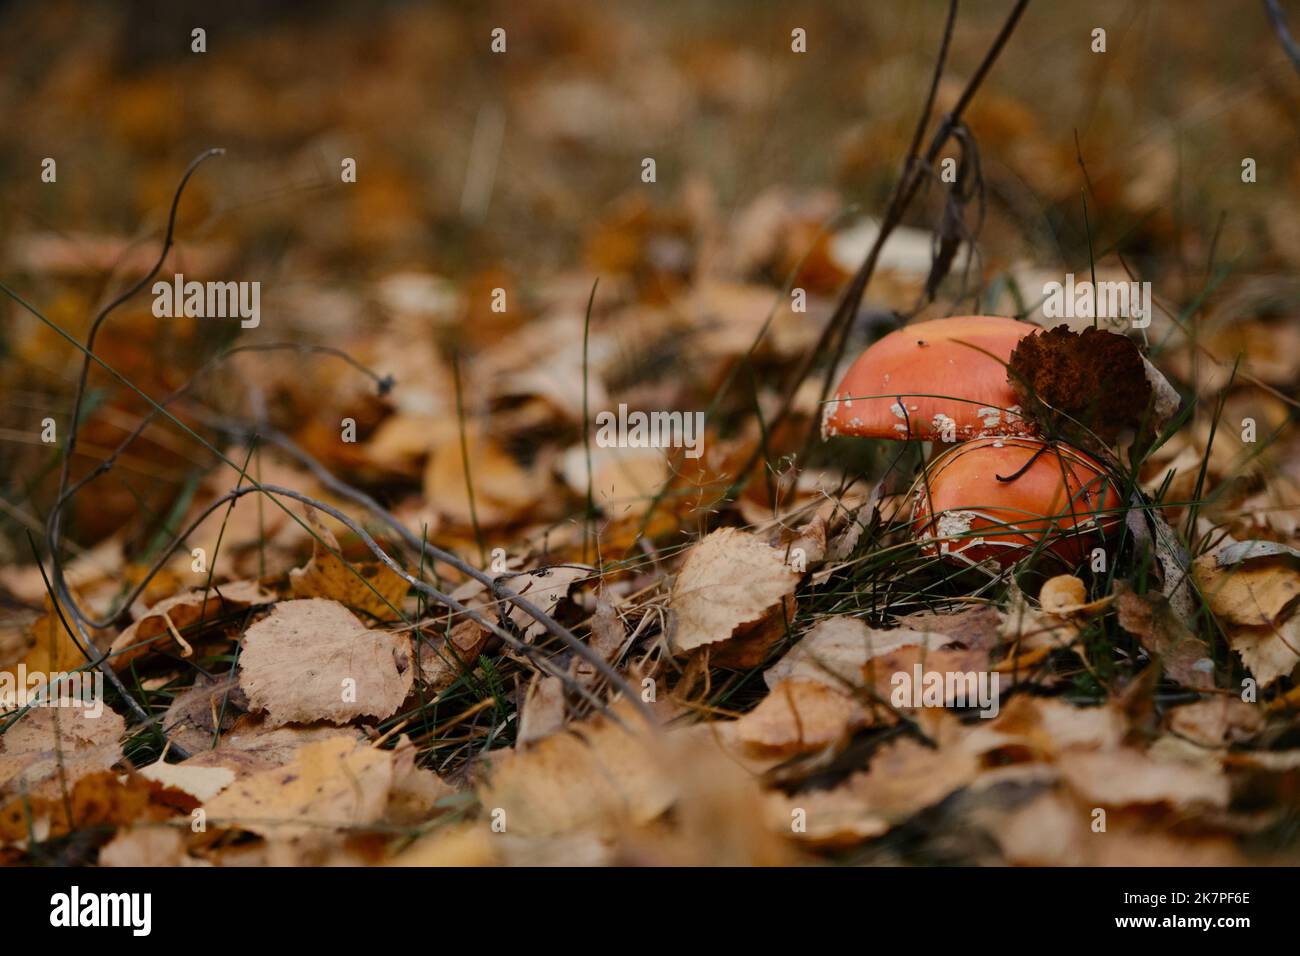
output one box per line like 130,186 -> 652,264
239,597 -> 415,727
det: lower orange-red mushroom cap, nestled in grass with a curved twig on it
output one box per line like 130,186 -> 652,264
911,438 -> 1122,567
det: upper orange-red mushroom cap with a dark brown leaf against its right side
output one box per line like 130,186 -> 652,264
822,315 -> 1039,442
